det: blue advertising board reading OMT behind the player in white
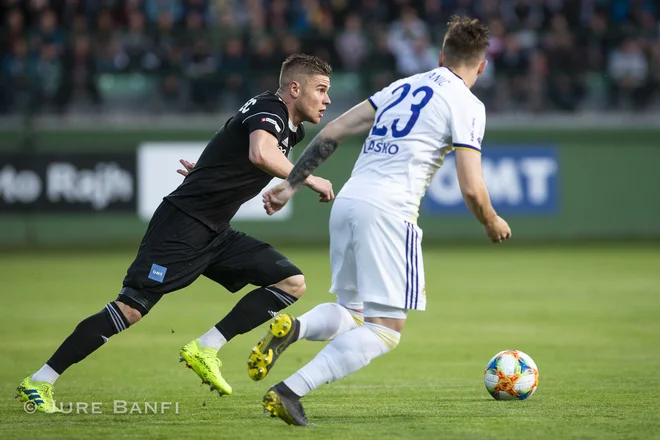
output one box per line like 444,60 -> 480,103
422,146 -> 560,215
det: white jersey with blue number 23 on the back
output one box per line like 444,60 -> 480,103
337,67 -> 486,223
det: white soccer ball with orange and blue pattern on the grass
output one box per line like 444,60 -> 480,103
484,350 -> 539,400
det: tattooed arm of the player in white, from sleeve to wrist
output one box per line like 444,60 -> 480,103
286,101 -> 375,191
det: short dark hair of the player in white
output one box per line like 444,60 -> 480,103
442,15 -> 488,67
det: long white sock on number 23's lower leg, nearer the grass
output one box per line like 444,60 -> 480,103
284,322 -> 401,397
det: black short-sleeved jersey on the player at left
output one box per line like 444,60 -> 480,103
165,92 -> 305,231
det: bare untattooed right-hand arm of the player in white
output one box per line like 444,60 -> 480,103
456,150 -> 511,243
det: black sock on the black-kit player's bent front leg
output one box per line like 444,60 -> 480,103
215,286 -> 298,341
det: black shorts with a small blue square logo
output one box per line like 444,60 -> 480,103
119,200 -> 302,314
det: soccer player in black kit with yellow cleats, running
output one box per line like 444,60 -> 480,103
17,54 -> 334,413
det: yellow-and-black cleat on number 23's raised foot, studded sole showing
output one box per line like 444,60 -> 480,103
248,313 -> 300,380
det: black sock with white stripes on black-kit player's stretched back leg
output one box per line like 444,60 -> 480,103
46,301 -> 129,374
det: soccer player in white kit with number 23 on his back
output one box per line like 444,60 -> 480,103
248,17 -> 511,425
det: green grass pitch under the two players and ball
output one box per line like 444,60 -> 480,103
0,246 -> 660,440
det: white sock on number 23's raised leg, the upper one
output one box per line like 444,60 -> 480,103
298,303 -> 364,341
